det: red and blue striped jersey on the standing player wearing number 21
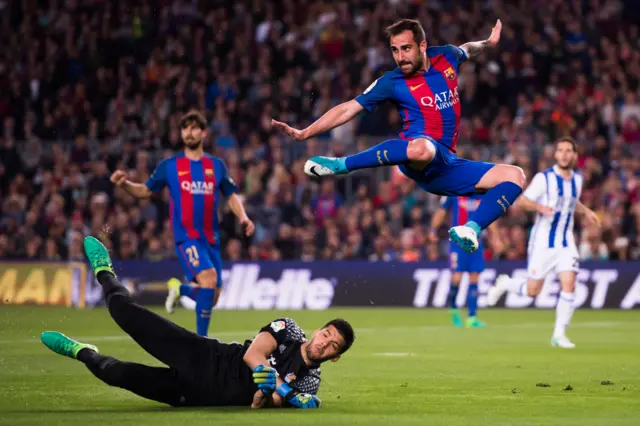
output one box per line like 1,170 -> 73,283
146,153 -> 238,244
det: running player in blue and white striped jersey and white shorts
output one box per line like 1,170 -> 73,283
487,137 -> 600,348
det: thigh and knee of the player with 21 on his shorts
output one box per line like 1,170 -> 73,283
176,239 -> 217,288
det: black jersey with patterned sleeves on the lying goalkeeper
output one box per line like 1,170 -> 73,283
208,318 -> 320,405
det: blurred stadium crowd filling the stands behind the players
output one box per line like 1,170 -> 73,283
0,0 -> 640,261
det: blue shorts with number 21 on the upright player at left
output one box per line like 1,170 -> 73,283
176,239 -> 222,287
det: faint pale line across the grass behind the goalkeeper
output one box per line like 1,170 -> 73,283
0,318 -> 636,344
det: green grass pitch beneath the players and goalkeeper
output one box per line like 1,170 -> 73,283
0,306 -> 640,426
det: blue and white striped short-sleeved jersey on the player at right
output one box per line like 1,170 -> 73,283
523,166 -> 583,251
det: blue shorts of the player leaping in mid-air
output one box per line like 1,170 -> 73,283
399,136 -> 495,196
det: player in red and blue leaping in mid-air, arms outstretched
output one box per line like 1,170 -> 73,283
272,19 -> 525,252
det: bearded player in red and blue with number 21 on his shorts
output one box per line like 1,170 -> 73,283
111,111 -> 255,336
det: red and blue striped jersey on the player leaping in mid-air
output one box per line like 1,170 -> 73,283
356,45 -> 467,152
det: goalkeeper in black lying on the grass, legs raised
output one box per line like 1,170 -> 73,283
40,237 -> 355,408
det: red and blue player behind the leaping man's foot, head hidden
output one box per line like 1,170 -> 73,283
429,194 -> 500,328
